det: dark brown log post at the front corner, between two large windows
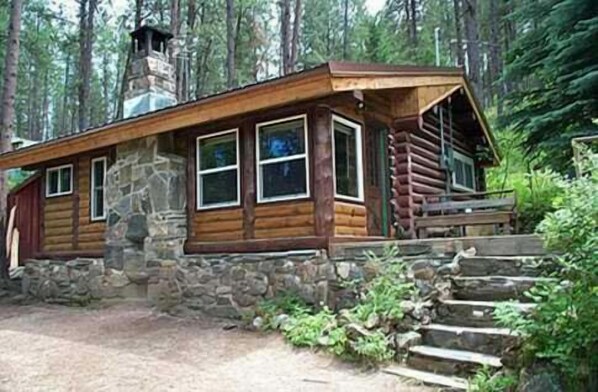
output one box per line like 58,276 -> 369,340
310,106 -> 334,237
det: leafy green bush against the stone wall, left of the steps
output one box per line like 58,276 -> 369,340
268,248 -> 415,364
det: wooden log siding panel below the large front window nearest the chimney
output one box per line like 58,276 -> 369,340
188,208 -> 243,242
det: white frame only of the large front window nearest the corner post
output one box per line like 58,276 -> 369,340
255,114 -> 310,204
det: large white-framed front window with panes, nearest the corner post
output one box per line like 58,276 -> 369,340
256,115 -> 309,202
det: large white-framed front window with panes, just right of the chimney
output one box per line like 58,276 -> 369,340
197,129 -> 241,209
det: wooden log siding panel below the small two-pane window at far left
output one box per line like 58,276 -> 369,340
43,195 -> 74,252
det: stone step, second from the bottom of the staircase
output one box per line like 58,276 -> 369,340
407,345 -> 502,377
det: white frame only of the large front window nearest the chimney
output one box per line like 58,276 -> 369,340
195,128 -> 241,211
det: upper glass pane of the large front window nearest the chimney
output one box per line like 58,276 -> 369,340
199,133 -> 237,170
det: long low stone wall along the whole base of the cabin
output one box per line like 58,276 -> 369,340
22,251 -> 458,318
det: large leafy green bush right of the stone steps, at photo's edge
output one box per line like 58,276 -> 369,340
496,148 -> 598,390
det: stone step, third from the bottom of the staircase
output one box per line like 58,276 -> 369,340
419,324 -> 518,357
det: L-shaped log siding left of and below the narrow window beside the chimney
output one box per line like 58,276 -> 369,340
77,156 -> 106,250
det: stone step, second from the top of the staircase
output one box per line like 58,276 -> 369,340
452,276 -> 555,302
